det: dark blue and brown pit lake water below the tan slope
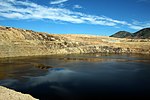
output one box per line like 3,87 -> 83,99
0,54 -> 150,100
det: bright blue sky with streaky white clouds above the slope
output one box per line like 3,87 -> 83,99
0,0 -> 150,36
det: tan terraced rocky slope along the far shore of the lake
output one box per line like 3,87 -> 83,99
0,26 -> 150,58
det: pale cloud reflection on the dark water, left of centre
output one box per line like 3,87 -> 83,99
28,68 -> 75,86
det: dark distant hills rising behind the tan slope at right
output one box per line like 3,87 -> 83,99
110,28 -> 150,39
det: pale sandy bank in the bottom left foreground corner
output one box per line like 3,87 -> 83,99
0,86 -> 38,100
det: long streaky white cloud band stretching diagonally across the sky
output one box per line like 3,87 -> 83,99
0,0 -> 150,30
